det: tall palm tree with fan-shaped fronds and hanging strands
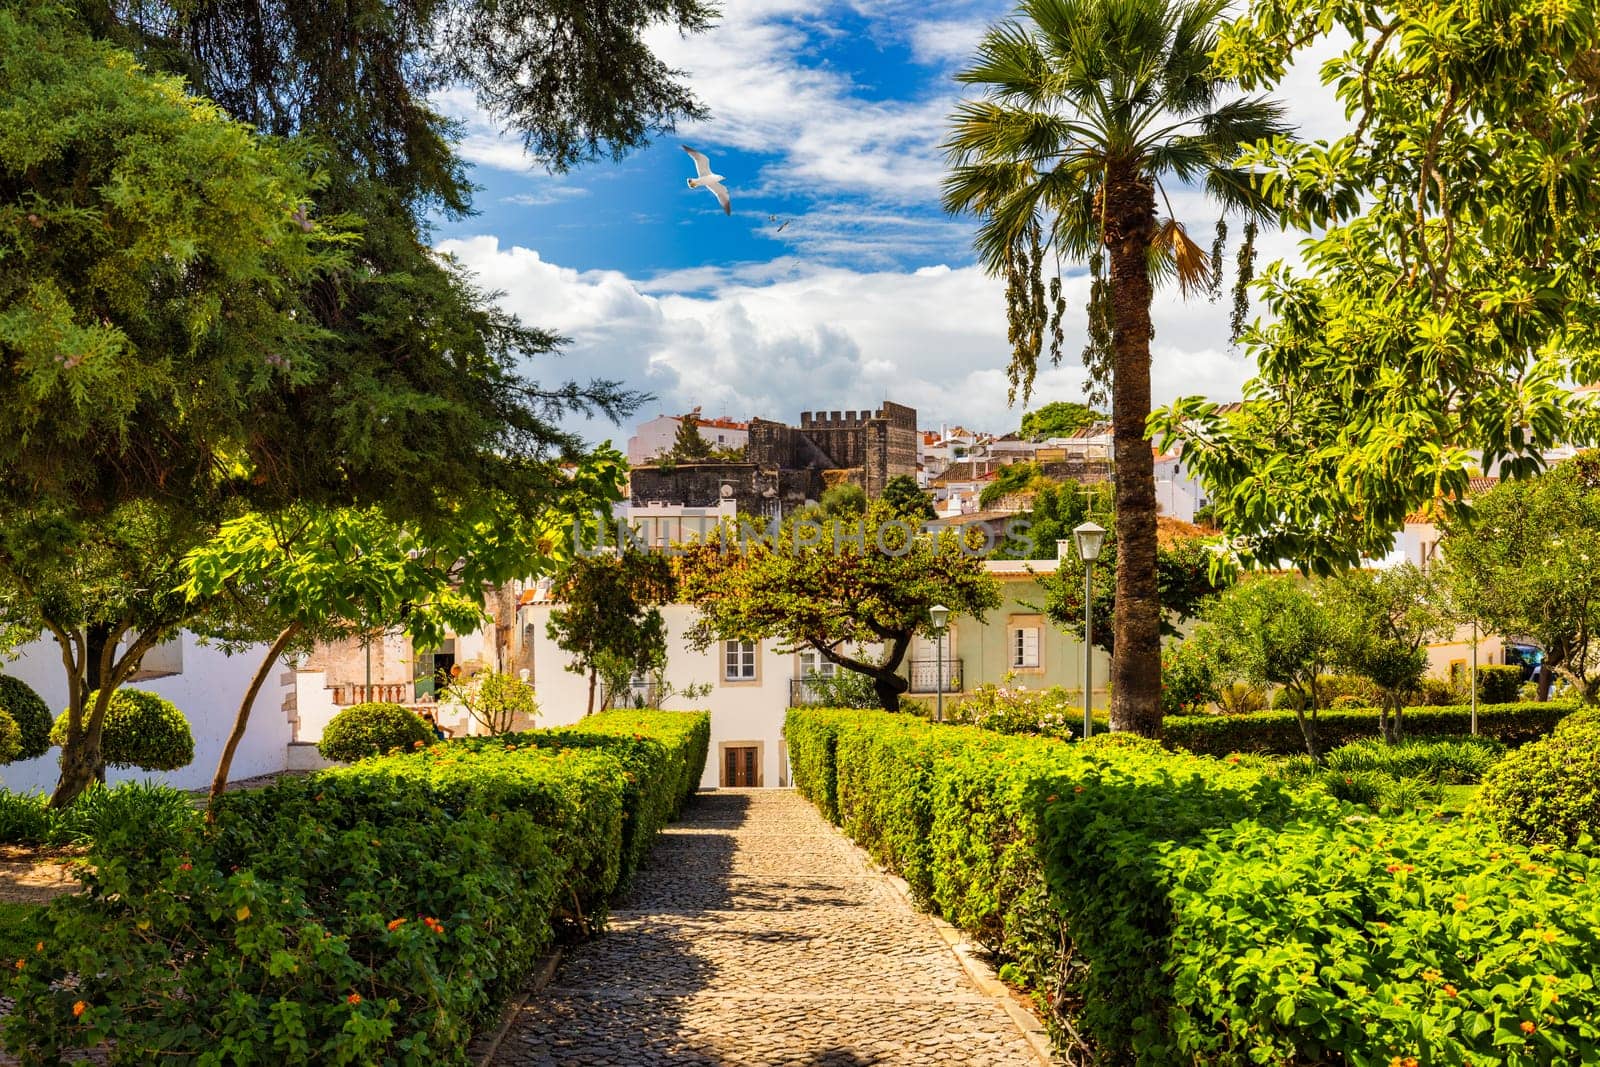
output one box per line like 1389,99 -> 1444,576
944,0 -> 1286,736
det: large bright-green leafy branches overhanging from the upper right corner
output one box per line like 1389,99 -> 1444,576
1158,0 -> 1600,573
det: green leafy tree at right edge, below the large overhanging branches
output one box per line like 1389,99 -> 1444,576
1442,451 -> 1600,704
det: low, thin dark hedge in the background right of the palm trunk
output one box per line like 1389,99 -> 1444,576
1162,701 -> 1578,755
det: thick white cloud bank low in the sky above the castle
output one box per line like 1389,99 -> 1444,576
442,237 -> 1250,438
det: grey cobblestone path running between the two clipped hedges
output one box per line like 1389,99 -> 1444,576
493,790 -> 1040,1067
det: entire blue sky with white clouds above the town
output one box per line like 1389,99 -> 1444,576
435,0 -> 1328,442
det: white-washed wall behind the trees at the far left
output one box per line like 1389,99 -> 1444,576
0,633 -> 291,792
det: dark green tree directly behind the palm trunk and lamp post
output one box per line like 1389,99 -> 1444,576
1040,523 -> 1235,656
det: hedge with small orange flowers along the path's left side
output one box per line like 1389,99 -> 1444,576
0,712 -> 710,1064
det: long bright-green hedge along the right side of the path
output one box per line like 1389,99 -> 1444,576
787,709 -> 1600,1067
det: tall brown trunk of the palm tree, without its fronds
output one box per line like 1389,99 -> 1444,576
1102,163 -> 1162,737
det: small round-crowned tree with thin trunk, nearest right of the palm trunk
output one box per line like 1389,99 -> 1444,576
1190,574 -> 1339,760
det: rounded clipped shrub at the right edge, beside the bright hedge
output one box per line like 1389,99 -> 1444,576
1478,721 -> 1600,846
